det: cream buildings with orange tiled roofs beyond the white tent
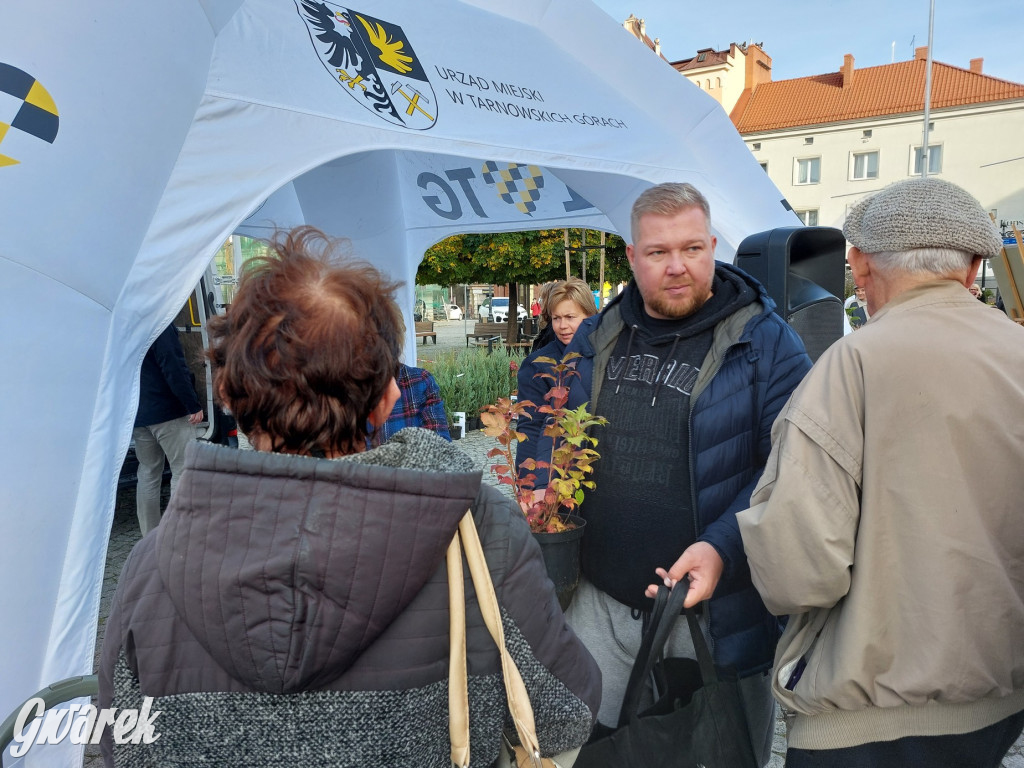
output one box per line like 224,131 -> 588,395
624,24 -> 1024,282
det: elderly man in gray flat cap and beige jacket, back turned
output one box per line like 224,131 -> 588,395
739,178 -> 1024,768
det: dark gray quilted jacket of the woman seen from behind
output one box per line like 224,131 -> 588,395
99,429 -> 600,768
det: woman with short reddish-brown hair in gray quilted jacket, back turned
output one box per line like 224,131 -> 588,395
99,228 -> 600,768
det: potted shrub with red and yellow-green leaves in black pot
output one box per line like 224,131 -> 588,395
480,352 -> 607,608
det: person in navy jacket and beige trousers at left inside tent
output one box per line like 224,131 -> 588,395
131,324 -> 203,536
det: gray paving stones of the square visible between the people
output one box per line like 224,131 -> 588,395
84,339 -> 1024,768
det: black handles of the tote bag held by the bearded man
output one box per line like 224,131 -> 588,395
618,577 -> 718,728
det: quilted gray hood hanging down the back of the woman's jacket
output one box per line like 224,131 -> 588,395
156,428 -> 481,693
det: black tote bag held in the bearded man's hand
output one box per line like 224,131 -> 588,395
575,580 -> 759,768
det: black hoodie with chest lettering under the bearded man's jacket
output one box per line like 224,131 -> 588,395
582,269 -> 758,608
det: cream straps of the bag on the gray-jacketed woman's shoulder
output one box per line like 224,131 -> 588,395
447,511 -> 542,768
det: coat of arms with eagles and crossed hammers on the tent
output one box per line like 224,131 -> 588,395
296,0 -> 437,130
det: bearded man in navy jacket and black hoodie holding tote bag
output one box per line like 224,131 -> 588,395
541,183 -> 811,765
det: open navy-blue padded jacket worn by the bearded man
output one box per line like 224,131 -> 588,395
561,262 -> 811,675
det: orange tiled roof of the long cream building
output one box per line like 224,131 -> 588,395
731,59 -> 1024,133
